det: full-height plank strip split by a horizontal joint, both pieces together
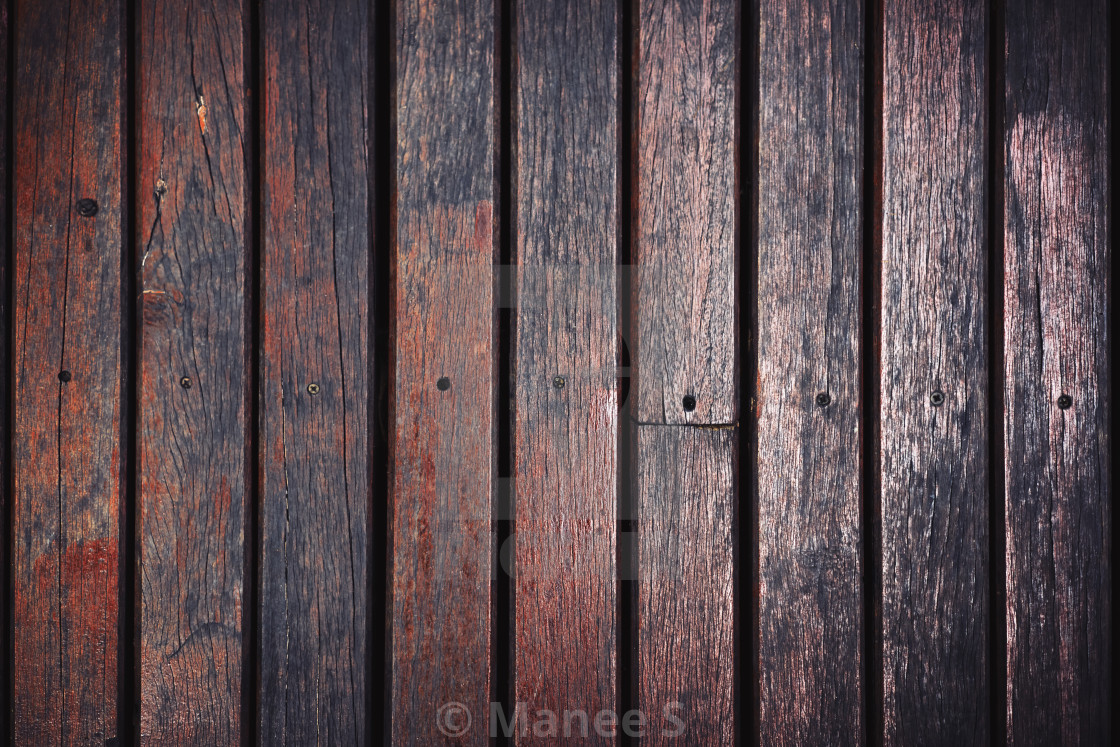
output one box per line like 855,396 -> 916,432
628,0 -> 739,744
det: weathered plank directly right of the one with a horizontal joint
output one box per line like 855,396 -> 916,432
755,0 -> 866,745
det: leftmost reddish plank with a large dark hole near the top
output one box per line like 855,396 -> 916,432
12,0 -> 124,745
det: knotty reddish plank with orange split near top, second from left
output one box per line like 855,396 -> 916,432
134,0 -> 248,745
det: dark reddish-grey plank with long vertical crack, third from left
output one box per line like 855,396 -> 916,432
259,0 -> 372,745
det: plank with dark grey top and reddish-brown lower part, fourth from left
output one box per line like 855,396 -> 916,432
391,1 -> 496,745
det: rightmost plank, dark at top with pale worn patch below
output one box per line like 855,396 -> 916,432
996,0 -> 1112,745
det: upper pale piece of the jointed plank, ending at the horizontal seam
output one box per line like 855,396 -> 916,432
633,0 -> 739,423
